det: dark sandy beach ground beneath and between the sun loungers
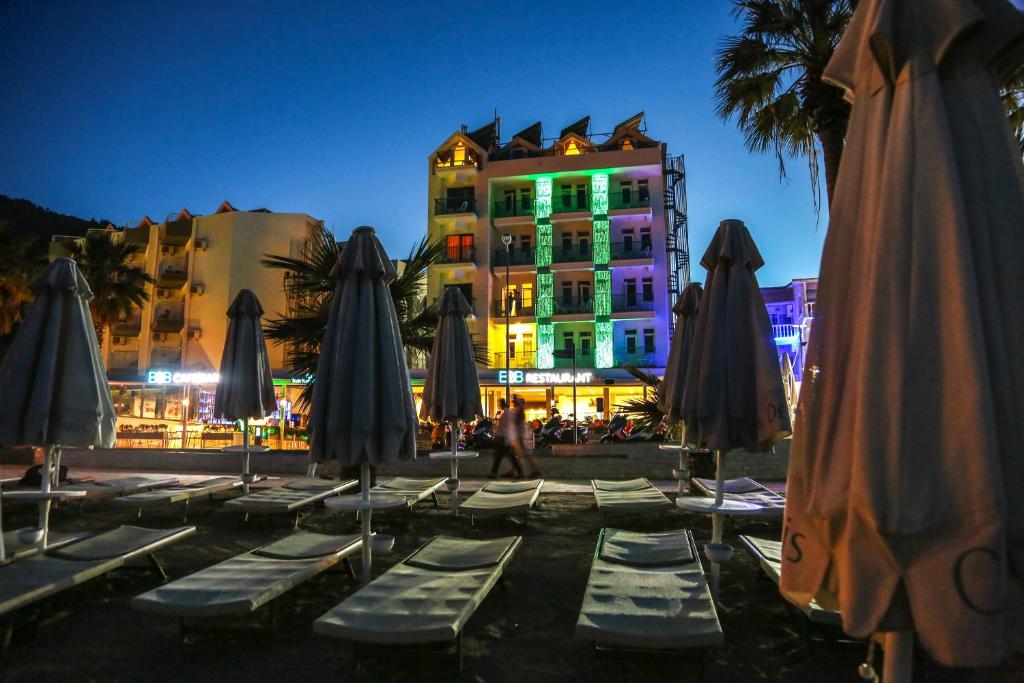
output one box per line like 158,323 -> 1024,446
0,473 -> 1024,683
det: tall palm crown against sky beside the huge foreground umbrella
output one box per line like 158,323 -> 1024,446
715,0 -> 852,205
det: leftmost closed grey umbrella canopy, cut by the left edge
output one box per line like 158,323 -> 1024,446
0,258 -> 117,449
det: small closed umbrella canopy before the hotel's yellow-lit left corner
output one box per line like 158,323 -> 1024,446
420,287 -> 483,422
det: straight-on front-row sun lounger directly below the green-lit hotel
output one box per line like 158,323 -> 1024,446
575,528 -> 722,650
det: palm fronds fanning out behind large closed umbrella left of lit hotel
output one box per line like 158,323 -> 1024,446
262,226 -> 475,402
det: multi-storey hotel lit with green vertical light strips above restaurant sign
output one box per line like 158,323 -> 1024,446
419,114 -> 689,418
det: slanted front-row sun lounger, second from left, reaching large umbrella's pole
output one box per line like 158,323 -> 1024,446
131,531 -> 362,618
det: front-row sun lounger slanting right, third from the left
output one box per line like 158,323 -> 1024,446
313,536 -> 522,645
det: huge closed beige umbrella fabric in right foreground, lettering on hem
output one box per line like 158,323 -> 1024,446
781,0 -> 1024,666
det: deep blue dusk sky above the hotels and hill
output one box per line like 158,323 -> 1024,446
0,0 -> 827,285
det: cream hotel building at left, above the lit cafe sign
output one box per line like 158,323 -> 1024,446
50,202 -> 321,447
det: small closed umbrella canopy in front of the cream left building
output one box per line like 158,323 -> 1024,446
213,290 -> 278,420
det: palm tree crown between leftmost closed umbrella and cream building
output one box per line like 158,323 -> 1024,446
67,230 -> 156,347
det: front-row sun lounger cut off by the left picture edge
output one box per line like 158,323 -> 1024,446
0,526 -> 196,615
